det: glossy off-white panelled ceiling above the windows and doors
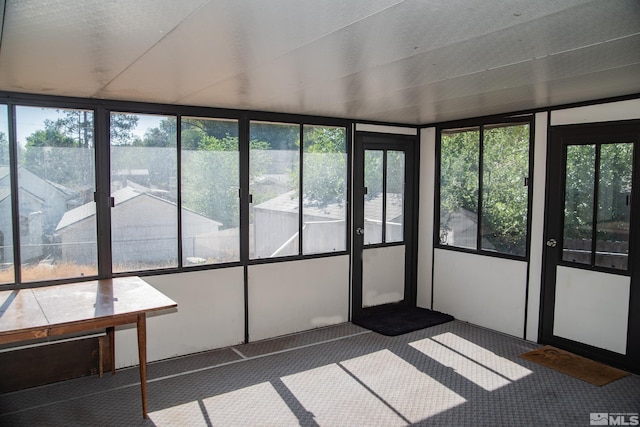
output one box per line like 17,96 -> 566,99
0,0 -> 640,125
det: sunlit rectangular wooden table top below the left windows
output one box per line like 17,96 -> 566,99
0,277 -> 177,342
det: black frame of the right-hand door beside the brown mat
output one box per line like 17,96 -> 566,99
538,120 -> 640,373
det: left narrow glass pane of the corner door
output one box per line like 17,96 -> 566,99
364,150 -> 384,245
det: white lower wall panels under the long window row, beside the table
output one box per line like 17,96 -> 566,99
116,255 -> 350,368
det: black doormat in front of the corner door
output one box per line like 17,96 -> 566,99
352,306 -> 454,337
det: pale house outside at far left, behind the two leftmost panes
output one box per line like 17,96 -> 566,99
0,166 -> 79,263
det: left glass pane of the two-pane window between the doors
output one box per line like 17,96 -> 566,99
439,128 -> 480,249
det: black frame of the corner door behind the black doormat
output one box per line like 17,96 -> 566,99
351,131 -> 419,319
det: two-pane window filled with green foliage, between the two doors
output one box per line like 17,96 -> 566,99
438,123 -> 530,257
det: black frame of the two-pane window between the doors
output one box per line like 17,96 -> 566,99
433,114 -> 535,262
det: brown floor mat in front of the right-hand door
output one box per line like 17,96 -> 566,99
520,345 -> 629,386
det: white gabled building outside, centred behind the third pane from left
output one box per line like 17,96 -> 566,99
56,185 -> 225,265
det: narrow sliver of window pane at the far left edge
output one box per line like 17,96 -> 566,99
0,105 -> 15,284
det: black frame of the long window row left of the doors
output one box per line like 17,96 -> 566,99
0,92 -> 355,290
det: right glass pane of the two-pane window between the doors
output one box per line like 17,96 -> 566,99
480,124 -> 529,256
